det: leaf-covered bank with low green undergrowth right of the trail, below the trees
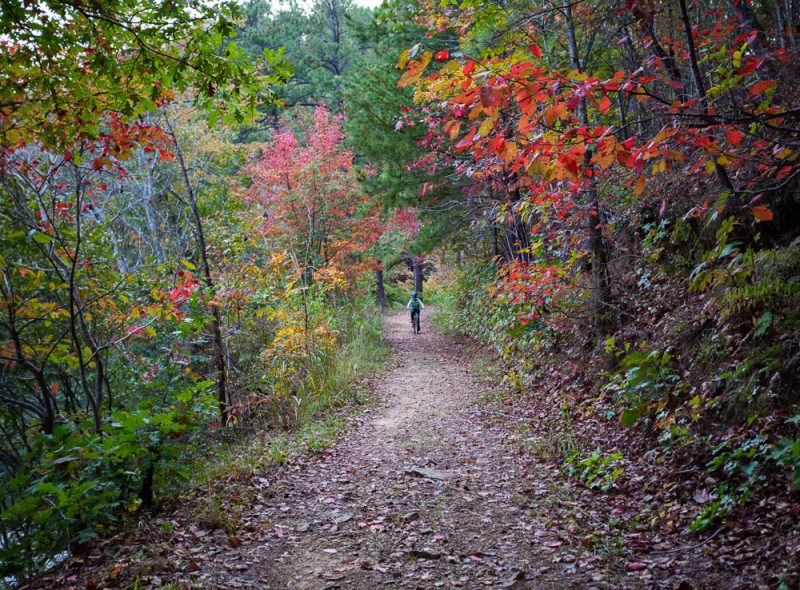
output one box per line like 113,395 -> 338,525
429,194 -> 800,588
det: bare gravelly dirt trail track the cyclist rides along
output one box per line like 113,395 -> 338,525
195,313 -> 591,590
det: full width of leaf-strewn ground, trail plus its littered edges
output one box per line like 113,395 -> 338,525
18,314 -> 780,590
